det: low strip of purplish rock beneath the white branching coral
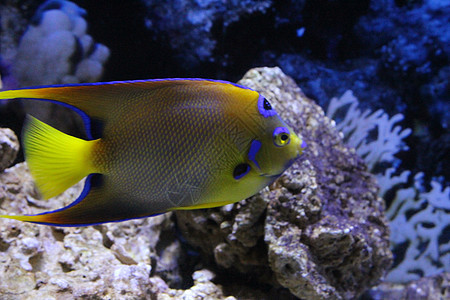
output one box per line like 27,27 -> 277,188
364,273 -> 450,300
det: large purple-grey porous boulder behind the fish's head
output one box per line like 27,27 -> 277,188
176,68 -> 392,299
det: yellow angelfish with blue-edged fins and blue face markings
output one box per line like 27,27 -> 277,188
0,78 -> 306,226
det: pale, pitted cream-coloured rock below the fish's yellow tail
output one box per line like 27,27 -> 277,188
0,163 -> 179,299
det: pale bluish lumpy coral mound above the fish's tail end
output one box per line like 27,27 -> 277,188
13,0 -> 109,86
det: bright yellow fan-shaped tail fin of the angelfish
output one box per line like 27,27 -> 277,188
23,116 -> 99,199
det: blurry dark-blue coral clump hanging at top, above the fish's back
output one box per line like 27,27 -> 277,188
144,0 -> 271,67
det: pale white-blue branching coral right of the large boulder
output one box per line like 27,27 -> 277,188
327,91 -> 450,282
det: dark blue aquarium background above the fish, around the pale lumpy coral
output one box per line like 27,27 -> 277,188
2,0 -> 450,184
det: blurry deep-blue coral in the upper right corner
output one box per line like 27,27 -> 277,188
355,0 -> 450,128
